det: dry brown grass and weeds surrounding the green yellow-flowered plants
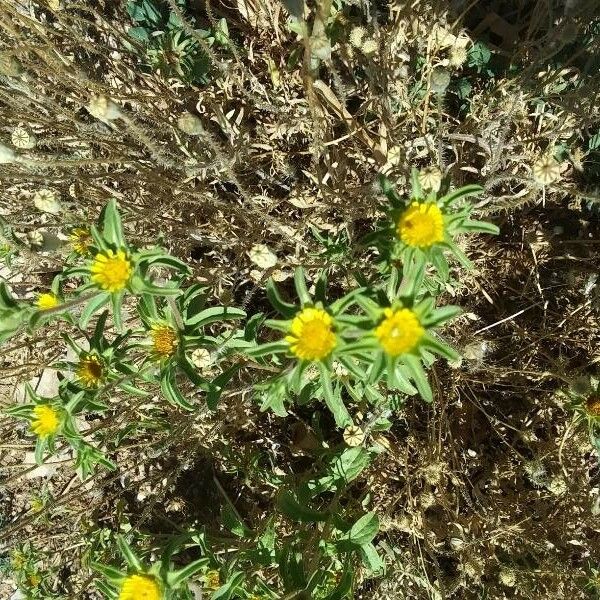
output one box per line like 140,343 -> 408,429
0,0 -> 600,600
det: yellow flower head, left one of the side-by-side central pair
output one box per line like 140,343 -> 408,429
285,308 -> 337,360
